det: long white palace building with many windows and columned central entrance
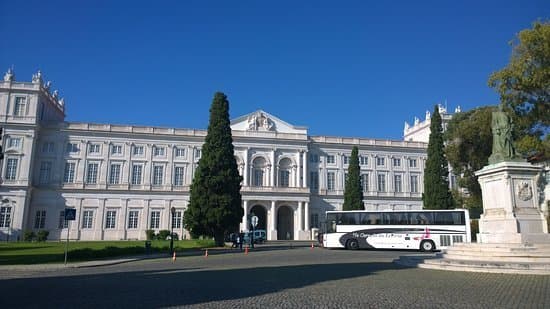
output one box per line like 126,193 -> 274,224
0,70 -> 427,240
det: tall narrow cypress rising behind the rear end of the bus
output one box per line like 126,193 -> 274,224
422,105 -> 455,209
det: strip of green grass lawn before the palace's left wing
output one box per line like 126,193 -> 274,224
0,240 -> 214,265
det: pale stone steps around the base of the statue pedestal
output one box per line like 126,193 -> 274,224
394,243 -> 550,275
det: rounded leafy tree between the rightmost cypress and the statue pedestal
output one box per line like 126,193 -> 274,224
444,106 -> 495,211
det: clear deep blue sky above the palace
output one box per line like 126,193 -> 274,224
0,0 -> 550,139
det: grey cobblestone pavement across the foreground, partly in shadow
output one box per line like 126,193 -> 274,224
0,246 -> 550,308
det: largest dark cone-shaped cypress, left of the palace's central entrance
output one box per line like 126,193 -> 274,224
184,92 -> 244,246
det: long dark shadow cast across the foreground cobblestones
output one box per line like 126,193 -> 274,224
0,263 -> 402,308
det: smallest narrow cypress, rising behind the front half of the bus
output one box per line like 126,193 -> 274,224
343,146 -> 365,210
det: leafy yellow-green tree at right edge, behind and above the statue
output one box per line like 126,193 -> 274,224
489,22 -> 550,158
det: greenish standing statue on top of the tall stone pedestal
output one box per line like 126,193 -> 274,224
489,104 -> 518,164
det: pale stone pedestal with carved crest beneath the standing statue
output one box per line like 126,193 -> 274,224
476,161 -> 550,244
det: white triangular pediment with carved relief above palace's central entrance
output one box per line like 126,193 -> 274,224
231,110 -> 307,135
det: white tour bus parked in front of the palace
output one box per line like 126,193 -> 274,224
322,209 -> 471,251
